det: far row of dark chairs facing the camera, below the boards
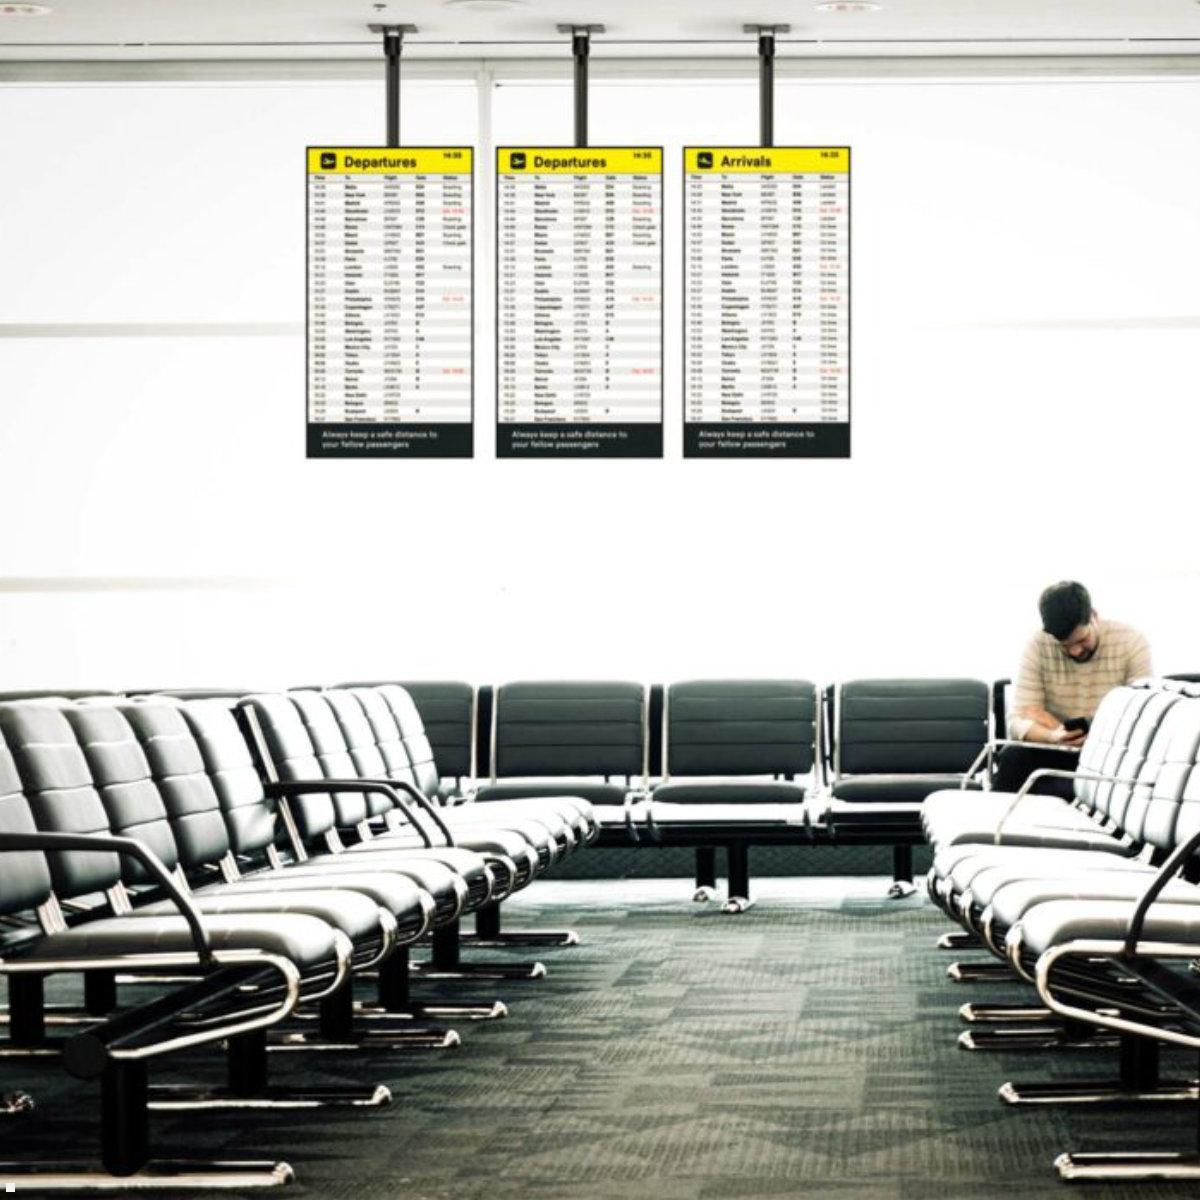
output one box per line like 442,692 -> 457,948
406,679 -> 994,912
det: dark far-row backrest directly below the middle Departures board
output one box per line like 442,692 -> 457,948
492,682 -> 647,779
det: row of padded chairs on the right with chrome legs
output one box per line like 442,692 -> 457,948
923,679 -> 1200,1180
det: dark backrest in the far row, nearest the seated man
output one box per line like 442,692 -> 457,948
833,679 -> 989,775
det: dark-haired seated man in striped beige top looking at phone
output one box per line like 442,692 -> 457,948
992,581 -> 1151,797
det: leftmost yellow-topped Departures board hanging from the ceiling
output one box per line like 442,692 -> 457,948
307,146 -> 474,458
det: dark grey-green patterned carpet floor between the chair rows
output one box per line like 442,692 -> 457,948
9,877 -> 1198,1200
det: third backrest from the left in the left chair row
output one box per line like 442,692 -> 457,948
62,701 -> 179,884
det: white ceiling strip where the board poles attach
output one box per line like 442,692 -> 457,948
0,0 -> 1200,61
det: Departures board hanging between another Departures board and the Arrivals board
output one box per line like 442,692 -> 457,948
496,146 -> 662,458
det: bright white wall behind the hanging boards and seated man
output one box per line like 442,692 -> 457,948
0,79 -> 1200,690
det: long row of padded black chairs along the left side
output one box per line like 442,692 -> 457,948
0,688 -> 599,1194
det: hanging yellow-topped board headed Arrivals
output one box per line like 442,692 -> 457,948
684,146 -> 850,458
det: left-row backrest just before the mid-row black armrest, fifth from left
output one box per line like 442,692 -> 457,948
179,700 -> 280,856
